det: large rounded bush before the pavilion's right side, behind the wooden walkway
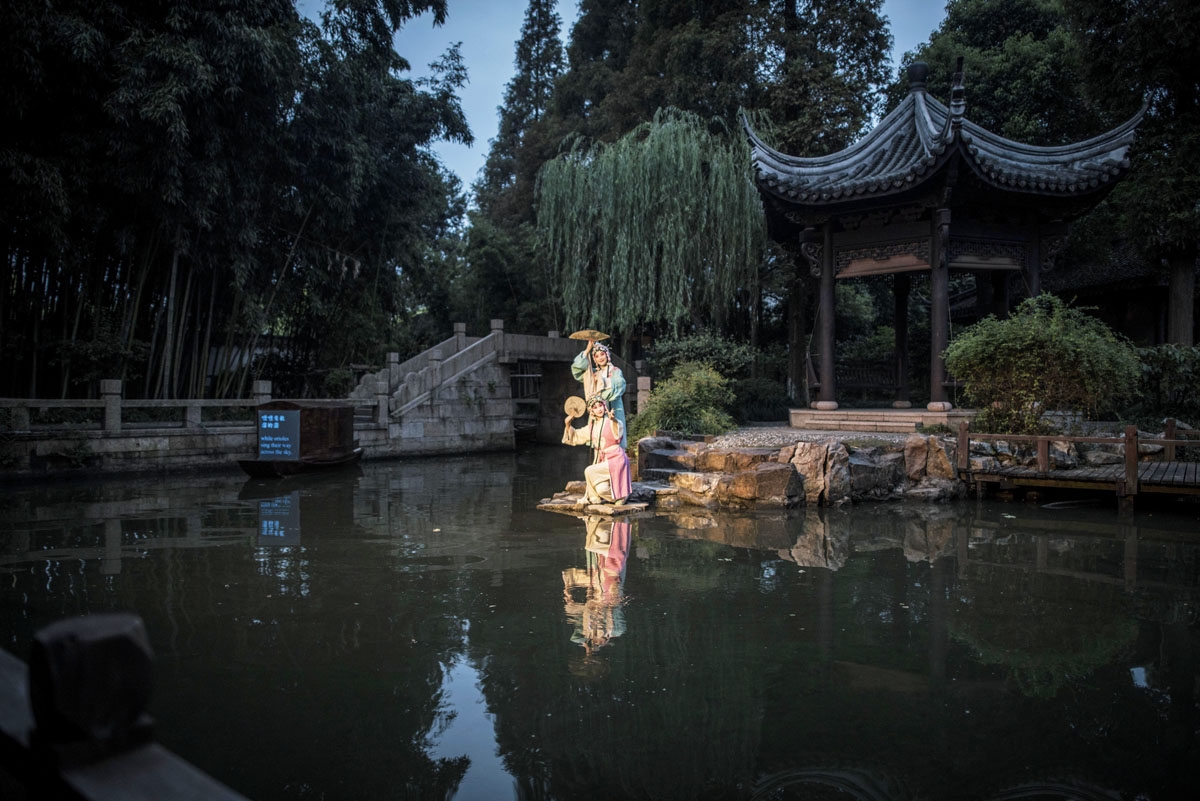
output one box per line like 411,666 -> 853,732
944,294 -> 1141,434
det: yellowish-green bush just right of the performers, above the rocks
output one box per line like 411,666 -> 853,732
629,362 -> 734,441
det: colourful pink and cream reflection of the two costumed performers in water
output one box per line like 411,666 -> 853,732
563,514 -> 632,655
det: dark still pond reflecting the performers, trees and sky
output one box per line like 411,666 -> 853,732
0,447 -> 1200,801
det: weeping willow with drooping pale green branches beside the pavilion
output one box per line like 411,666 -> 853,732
538,109 -> 764,337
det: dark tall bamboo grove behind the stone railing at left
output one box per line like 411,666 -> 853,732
0,0 -> 470,397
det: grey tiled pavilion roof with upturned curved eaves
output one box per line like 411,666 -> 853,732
743,64 -> 1146,206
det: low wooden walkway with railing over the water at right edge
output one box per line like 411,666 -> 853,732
956,420 -> 1200,501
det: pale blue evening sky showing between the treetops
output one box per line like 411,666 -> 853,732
314,0 -> 946,195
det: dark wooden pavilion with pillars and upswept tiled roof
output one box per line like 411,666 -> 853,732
745,59 -> 1145,411
